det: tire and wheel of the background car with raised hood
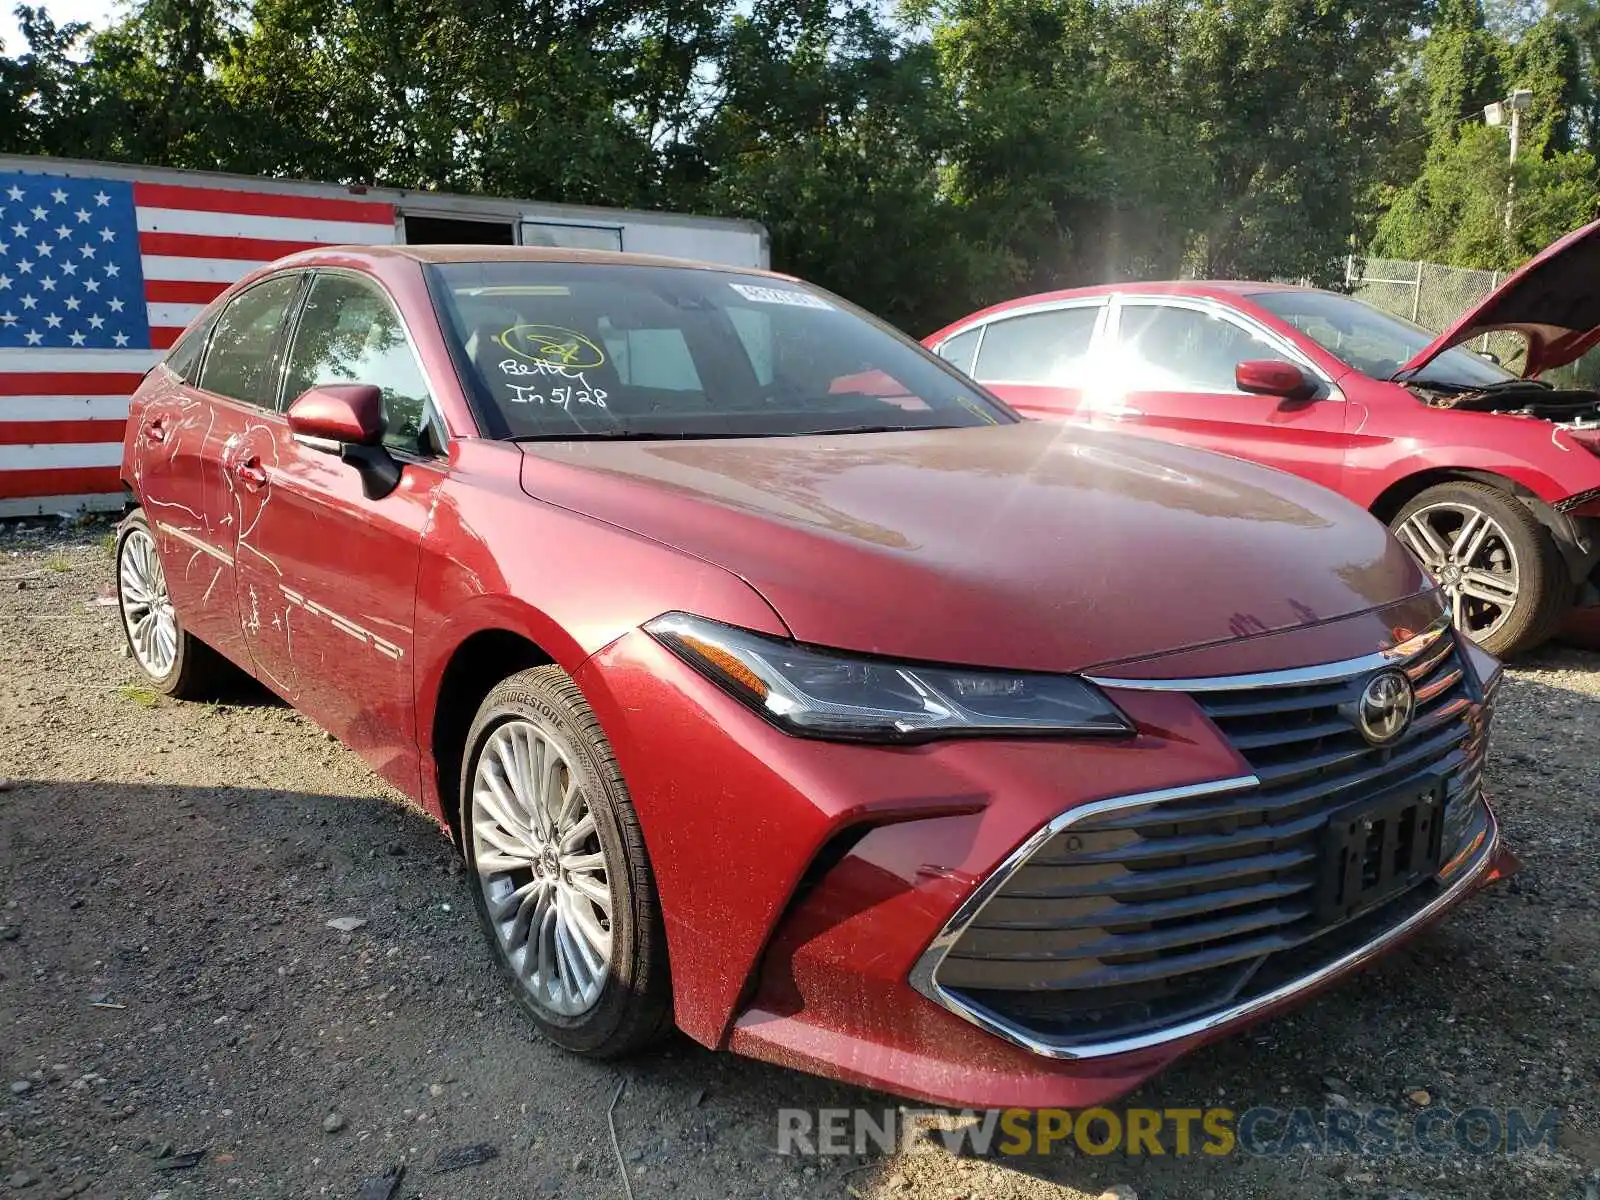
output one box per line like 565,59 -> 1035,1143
1389,482 -> 1573,658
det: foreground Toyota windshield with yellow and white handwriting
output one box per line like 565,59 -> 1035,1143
432,261 -> 1016,438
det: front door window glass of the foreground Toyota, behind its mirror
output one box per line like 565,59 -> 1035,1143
283,275 -> 429,454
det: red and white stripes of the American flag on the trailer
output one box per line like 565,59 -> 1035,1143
0,182 -> 395,517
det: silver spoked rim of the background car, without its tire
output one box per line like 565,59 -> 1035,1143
1395,504 -> 1522,642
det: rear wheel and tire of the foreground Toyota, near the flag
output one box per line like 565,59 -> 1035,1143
117,509 -> 230,699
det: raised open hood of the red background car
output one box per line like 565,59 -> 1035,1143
1394,221 -> 1600,379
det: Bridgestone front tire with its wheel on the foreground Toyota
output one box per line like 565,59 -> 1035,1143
461,667 -> 672,1058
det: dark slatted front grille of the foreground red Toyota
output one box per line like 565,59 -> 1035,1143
933,629 -> 1488,1045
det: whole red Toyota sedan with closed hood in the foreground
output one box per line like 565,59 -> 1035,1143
117,246 -> 1507,1106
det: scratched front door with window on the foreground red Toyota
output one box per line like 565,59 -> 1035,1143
238,270 -> 445,800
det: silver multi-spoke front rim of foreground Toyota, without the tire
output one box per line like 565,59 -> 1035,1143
472,718 -> 613,1018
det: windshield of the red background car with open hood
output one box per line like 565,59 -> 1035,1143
1250,291 -> 1517,390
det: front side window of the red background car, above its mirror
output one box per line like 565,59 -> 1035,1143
1117,304 -> 1283,392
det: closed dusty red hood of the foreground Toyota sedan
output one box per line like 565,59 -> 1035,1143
522,421 -> 1426,670
